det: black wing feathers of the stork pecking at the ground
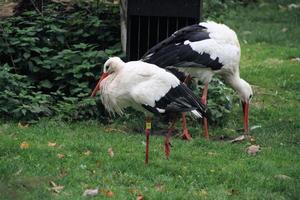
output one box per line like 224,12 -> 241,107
142,24 -> 223,70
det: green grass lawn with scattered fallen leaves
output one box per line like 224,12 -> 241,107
0,1 -> 300,199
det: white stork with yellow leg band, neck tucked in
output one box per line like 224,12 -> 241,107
91,57 -> 207,163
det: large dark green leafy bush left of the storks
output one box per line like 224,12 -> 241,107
0,2 -> 121,120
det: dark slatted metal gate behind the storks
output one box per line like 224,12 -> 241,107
121,0 -> 202,60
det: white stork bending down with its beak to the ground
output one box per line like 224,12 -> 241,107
141,21 -> 253,139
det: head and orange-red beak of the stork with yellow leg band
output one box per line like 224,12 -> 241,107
91,57 -> 124,97
